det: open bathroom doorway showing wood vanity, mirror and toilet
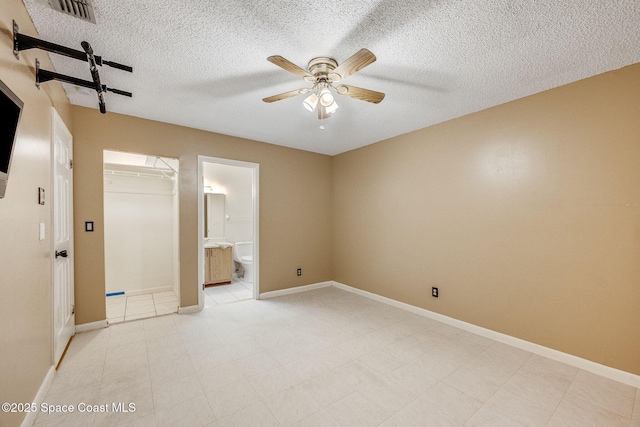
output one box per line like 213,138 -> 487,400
198,156 -> 260,308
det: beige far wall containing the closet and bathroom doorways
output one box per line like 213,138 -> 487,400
72,107 -> 331,324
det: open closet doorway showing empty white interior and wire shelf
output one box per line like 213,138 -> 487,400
103,150 -> 180,323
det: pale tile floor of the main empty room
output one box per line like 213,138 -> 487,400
36,287 -> 640,427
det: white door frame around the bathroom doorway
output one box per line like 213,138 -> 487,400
198,156 -> 260,309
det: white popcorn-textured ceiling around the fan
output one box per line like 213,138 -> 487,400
18,0 -> 640,155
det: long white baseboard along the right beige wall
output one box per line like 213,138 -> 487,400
332,282 -> 640,387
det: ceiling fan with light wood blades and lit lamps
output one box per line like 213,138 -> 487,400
263,49 -> 384,120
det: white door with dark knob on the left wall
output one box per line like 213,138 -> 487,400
51,109 -> 75,366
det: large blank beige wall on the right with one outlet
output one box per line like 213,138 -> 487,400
332,64 -> 640,374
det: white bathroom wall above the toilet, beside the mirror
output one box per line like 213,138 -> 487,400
204,163 -> 253,243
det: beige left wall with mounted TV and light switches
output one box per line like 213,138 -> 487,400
0,0 -> 71,426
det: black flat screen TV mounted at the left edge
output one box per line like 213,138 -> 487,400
0,80 -> 24,199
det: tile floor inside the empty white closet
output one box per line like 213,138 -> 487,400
106,291 -> 178,324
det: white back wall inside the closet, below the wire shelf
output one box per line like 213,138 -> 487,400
104,169 -> 178,294
